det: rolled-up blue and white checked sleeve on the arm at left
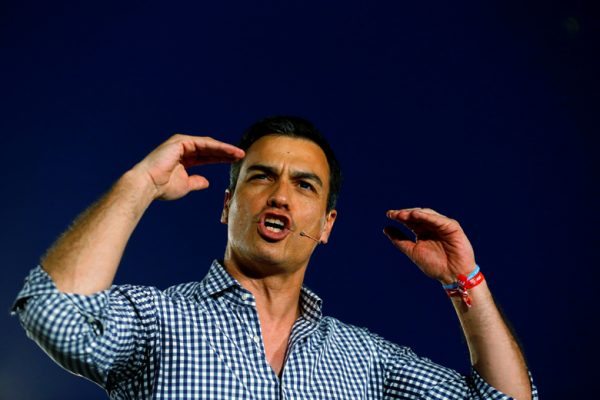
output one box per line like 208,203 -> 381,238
12,266 -> 157,390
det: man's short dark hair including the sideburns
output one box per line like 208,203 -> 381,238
229,115 -> 342,211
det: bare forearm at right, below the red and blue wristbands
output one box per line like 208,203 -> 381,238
452,281 -> 531,400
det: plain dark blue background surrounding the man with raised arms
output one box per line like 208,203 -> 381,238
0,0 -> 600,399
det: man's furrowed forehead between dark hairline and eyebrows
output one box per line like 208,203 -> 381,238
242,135 -> 329,177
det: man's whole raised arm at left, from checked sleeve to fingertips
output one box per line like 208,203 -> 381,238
13,135 -> 244,388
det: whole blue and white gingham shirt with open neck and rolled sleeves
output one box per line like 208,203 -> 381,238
13,261 -> 537,400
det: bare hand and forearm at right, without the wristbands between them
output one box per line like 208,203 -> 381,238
384,208 -> 532,400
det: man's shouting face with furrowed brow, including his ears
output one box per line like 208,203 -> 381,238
221,135 -> 336,272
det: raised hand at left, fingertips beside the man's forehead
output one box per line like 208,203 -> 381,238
134,134 -> 244,200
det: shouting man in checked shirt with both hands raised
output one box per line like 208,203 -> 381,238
15,117 -> 537,399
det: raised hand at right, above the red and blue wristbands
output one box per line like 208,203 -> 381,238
384,208 -> 475,284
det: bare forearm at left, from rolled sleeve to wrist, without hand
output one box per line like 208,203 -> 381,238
41,169 -> 155,295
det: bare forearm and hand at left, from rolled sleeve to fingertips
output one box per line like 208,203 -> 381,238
41,135 -> 244,295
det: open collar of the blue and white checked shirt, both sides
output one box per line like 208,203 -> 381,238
198,260 -> 323,322
